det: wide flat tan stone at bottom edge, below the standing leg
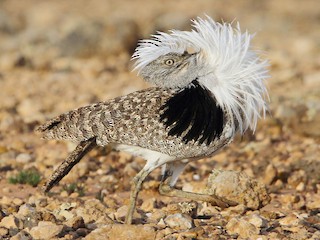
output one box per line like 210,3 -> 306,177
84,224 -> 156,240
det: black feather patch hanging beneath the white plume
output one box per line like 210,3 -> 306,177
160,80 -> 224,145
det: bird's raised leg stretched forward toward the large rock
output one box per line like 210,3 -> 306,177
159,169 -> 236,208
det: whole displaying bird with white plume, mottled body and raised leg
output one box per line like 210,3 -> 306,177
37,15 -> 269,224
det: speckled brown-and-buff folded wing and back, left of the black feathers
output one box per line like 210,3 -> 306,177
37,88 -> 174,146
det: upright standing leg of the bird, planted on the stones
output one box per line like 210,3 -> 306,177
125,168 -> 150,224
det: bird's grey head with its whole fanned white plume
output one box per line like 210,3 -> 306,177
132,16 -> 268,133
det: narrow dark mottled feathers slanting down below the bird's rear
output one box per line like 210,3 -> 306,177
43,138 -> 96,192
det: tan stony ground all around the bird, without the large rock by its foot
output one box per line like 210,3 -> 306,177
0,0 -> 320,240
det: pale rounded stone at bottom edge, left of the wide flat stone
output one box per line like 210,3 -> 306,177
30,221 -> 63,239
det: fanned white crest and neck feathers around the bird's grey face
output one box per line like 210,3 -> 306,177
132,16 -> 269,134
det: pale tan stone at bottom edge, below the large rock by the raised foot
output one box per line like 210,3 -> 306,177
226,217 -> 260,238
